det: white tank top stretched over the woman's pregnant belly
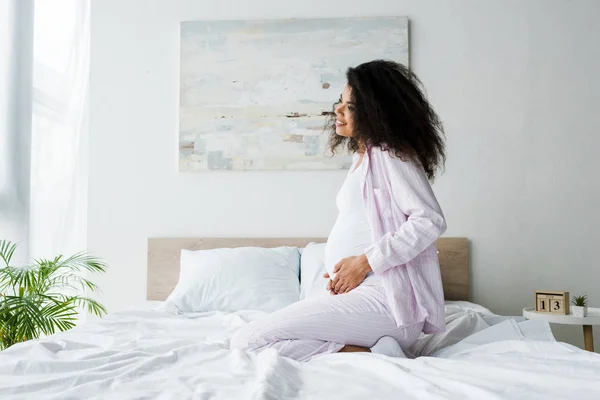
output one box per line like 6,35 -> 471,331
325,162 -> 377,283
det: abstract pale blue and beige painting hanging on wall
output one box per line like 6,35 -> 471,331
179,17 -> 409,171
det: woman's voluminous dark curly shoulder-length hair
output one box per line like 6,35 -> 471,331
327,60 -> 446,180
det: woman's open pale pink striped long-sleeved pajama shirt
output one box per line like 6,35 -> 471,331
363,147 -> 446,333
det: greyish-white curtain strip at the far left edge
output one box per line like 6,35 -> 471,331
0,0 -> 33,264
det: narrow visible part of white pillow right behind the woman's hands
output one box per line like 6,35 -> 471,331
300,243 -> 329,300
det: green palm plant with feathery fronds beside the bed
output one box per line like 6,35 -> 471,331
0,240 -> 106,350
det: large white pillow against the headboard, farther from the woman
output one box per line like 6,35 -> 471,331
166,247 -> 300,312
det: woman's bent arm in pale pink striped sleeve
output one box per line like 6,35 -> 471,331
365,155 -> 446,274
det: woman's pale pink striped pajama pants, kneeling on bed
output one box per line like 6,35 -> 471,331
231,284 -> 423,361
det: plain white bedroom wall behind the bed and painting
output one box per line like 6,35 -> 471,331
88,0 -> 600,346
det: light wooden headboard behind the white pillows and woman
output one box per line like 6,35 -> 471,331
146,238 -> 469,300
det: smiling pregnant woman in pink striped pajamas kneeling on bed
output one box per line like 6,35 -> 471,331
231,60 -> 446,361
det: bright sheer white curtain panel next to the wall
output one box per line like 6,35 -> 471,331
29,0 -> 90,257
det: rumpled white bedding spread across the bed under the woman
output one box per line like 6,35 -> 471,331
0,307 -> 600,400
